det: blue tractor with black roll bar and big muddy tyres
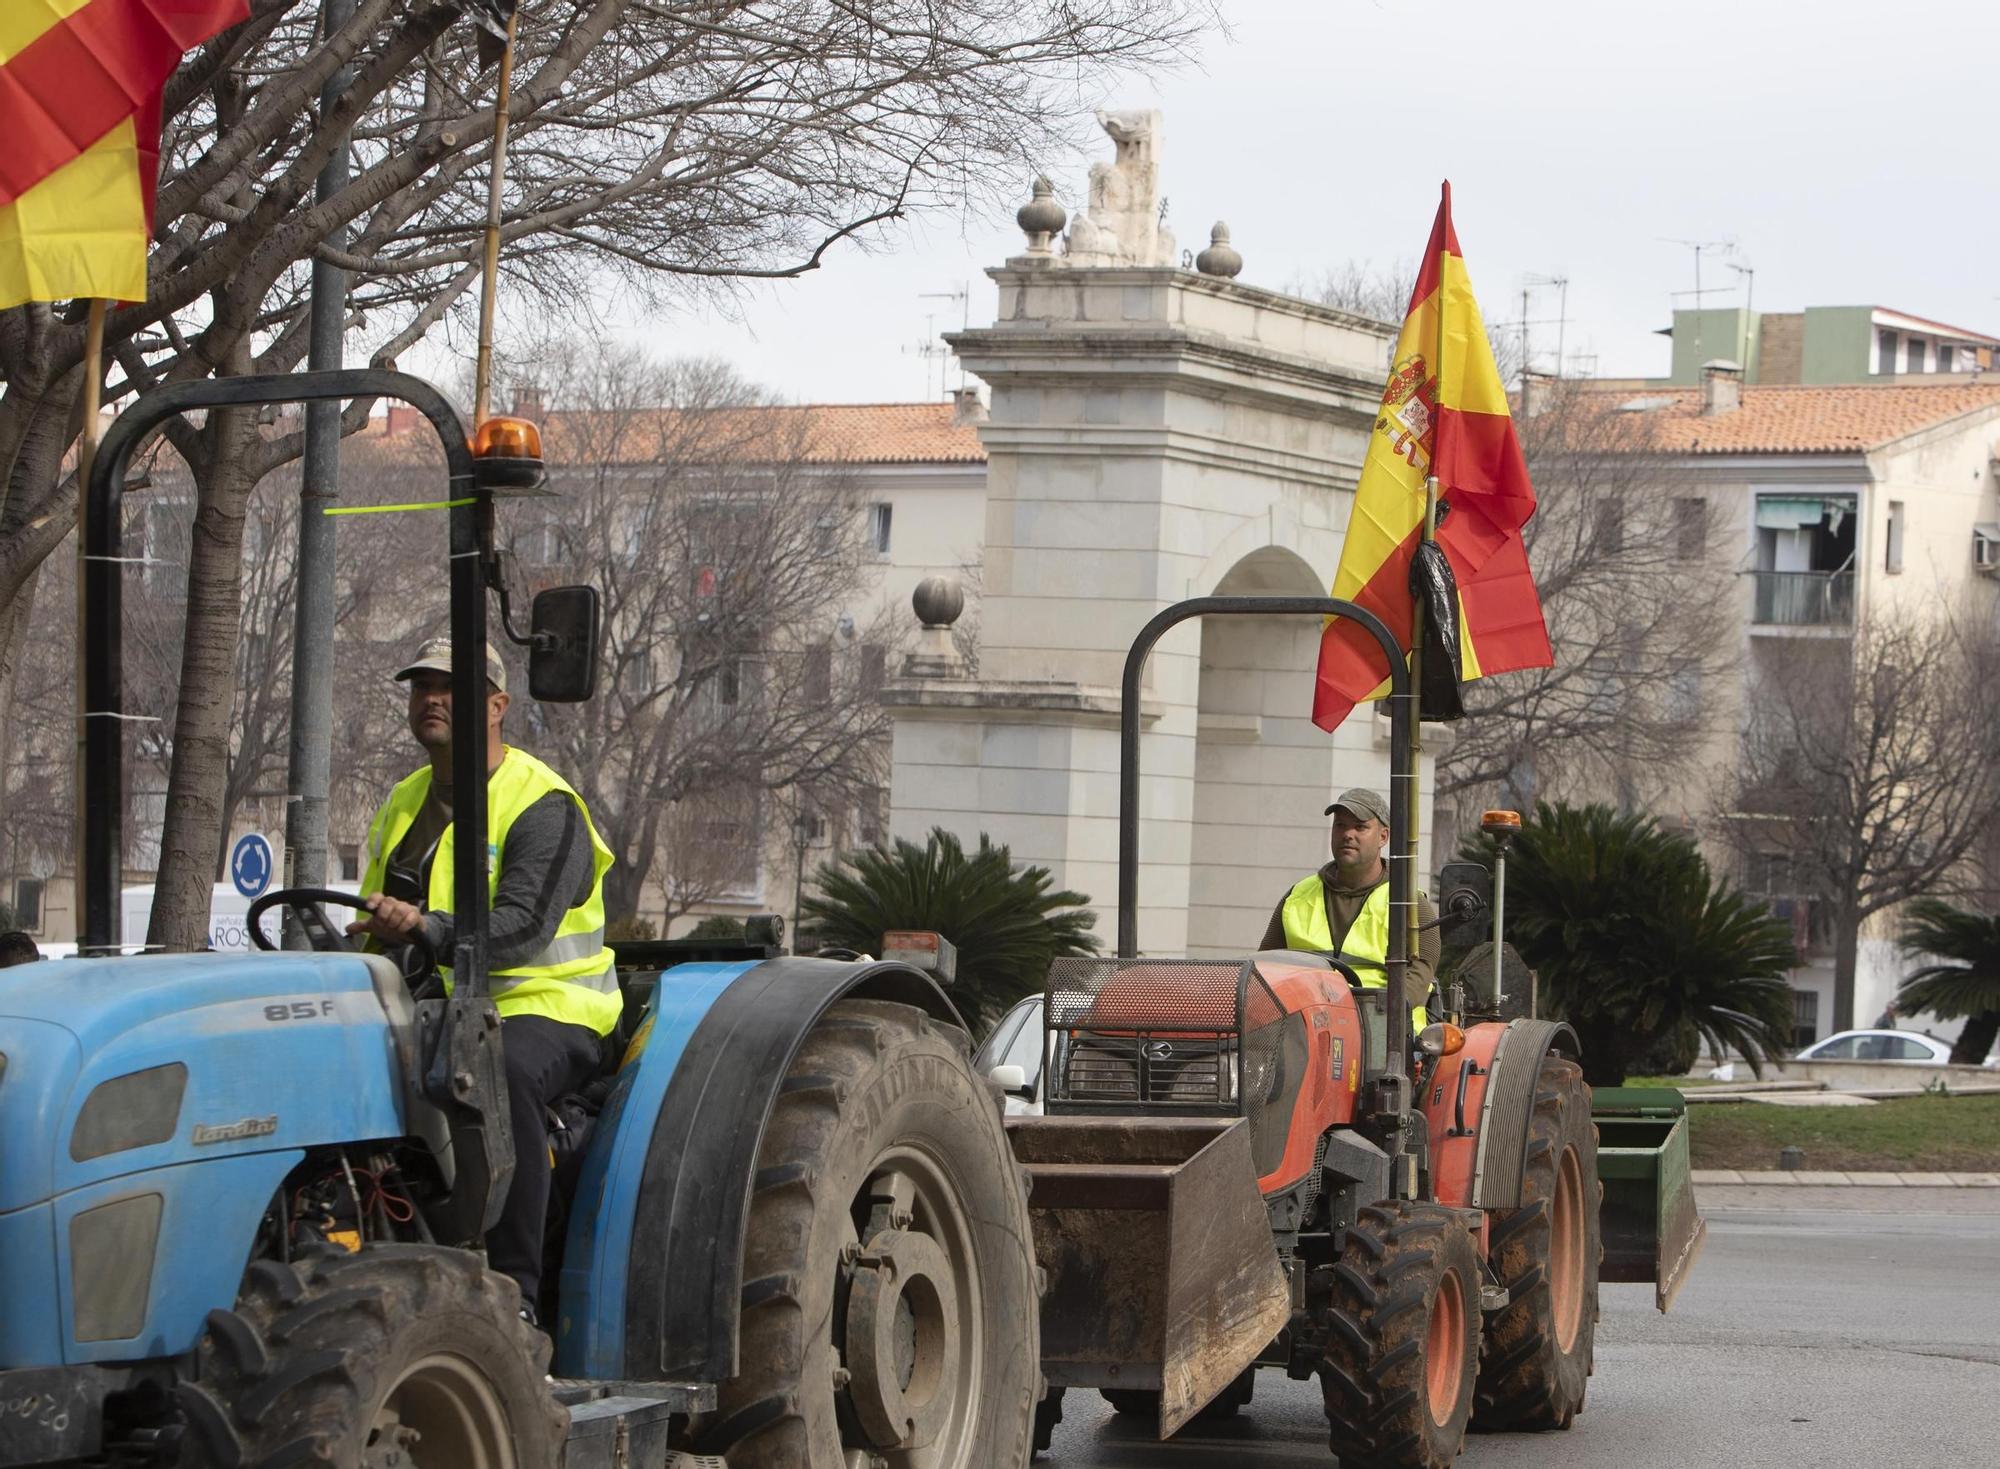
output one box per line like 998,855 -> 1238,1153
0,370 -> 1046,1469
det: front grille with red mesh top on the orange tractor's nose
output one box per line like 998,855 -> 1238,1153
1044,959 -> 1284,1115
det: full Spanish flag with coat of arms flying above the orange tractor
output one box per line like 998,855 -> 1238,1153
1312,184 -> 1554,730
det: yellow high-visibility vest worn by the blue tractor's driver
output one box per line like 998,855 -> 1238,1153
362,747 -> 624,1035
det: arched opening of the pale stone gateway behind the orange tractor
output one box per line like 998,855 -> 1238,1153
1188,546 -> 1344,957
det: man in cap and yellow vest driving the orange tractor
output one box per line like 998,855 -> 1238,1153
1260,787 -> 1438,1025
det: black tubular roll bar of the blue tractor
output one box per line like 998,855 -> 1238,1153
76,368 -> 486,995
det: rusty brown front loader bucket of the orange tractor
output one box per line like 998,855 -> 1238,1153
1006,1117 -> 1292,1439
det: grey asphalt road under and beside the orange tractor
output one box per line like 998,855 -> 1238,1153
1036,1189 -> 2000,1469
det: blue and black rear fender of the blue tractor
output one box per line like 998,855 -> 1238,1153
556,957 -> 966,1383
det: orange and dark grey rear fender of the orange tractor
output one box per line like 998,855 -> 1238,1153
1418,1021 -> 1582,1209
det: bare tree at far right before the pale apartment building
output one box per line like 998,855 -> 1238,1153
1728,608 -> 2000,1031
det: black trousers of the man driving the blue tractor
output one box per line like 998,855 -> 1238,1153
486,1015 -> 604,1309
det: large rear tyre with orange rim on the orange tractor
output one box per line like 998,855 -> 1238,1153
1472,1057 -> 1604,1431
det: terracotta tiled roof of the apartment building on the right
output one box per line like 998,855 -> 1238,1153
1590,378 -> 2000,454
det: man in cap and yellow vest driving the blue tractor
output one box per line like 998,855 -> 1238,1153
348,638 -> 622,1321
